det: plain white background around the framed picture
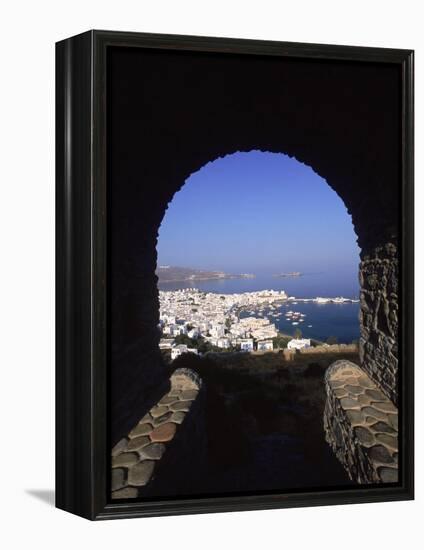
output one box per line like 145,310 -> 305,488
0,0 -> 424,550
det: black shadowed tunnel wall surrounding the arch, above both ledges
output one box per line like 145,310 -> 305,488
107,48 -> 401,442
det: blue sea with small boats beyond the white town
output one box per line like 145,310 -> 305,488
159,271 -> 359,343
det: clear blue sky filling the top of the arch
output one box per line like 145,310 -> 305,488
158,151 -> 359,273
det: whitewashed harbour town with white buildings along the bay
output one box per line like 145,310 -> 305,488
159,288 -> 354,360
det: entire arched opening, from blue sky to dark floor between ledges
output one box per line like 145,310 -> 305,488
151,151 -> 360,493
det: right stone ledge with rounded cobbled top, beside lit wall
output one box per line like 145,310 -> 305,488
324,360 -> 398,483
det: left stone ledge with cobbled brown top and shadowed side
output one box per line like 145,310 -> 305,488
111,369 -> 204,500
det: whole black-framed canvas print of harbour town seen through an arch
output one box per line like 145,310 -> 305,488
56,31 -> 413,519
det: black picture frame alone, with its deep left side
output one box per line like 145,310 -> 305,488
56,31 -> 414,520
